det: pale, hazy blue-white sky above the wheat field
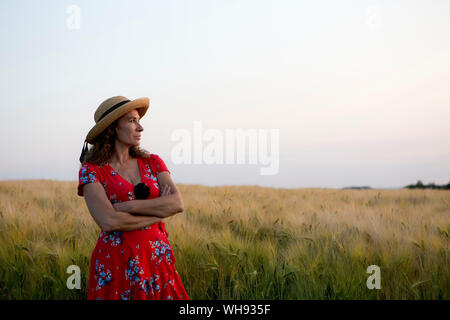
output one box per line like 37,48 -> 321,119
0,0 -> 450,188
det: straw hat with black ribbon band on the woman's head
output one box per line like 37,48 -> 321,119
80,96 -> 150,162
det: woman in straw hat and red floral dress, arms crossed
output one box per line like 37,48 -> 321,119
78,96 -> 189,300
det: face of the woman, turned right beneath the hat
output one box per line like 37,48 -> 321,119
115,109 -> 144,146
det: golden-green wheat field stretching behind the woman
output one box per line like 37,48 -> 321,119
0,180 -> 450,300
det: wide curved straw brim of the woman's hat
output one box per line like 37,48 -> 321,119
86,97 -> 150,144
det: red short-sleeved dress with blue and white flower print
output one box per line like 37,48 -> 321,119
78,154 -> 189,300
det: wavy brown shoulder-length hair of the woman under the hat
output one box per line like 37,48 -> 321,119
81,120 -> 150,166
